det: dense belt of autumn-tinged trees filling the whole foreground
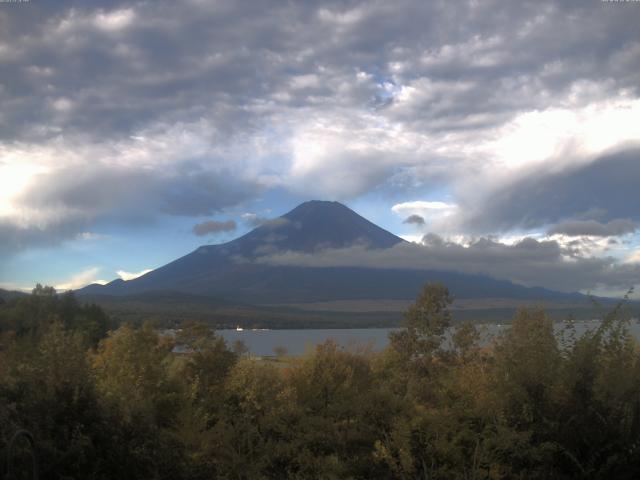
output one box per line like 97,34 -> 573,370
0,284 -> 640,479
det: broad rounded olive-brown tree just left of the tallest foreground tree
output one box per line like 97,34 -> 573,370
289,340 -> 395,478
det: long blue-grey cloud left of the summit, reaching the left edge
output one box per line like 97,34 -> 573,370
0,164 -> 261,252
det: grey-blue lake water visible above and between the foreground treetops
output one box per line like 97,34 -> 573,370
217,320 -> 640,356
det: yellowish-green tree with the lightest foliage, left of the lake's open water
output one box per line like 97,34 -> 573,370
91,324 -> 185,479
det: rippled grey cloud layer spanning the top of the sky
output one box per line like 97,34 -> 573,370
0,0 -> 640,146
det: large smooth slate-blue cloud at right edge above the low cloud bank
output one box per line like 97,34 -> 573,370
467,149 -> 640,234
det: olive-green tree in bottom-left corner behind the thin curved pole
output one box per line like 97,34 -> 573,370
0,322 -> 108,478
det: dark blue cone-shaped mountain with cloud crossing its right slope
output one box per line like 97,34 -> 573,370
77,201 -> 585,304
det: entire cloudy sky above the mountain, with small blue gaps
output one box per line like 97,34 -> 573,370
0,0 -> 640,295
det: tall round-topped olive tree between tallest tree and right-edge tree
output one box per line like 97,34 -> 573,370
485,309 -> 562,478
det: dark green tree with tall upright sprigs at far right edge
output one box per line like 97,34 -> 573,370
557,298 -> 640,478
